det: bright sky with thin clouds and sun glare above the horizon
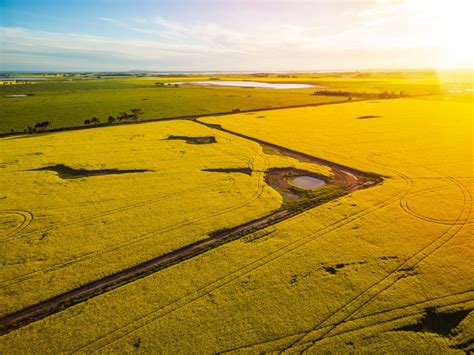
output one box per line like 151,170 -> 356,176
0,0 -> 474,71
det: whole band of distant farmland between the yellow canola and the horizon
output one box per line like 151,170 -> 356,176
0,72 -> 469,133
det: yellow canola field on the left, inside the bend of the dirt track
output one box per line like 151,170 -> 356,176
0,121 -> 329,314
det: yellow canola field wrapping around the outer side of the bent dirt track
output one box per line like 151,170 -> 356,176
0,99 -> 474,354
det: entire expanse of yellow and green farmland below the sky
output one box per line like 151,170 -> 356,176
0,73 -> 474,354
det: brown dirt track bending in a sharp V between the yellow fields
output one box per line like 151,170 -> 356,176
0,119 -> 382,334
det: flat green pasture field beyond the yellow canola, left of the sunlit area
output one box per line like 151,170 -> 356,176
0,78 -> 344,133
